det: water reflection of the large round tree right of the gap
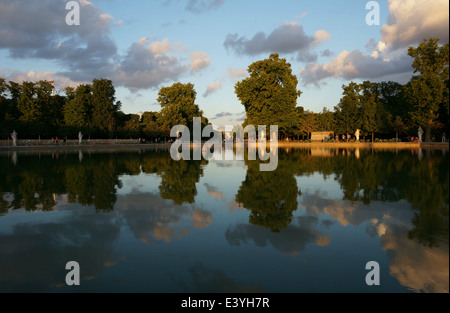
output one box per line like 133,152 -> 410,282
236,150 -> 299,232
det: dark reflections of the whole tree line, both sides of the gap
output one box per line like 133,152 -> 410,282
0,149 -> 449,247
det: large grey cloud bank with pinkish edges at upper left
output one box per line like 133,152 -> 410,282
0,0 -> 207,91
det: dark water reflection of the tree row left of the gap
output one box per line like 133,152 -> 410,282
0,151 -> 206,213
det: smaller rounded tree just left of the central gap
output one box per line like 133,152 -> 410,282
157,83 -> 203,130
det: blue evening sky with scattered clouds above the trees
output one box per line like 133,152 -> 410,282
0,0 -> 449,127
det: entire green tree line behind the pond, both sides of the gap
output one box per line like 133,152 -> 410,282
0,38 -> 449,141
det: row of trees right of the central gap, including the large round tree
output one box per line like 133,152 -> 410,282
235,38 -> 449,141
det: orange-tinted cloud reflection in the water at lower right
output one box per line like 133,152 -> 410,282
302,193 -> 449,293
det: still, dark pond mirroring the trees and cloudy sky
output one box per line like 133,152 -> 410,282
0,148 -> 449,293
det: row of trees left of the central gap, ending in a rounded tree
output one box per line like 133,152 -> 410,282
0,78 -> 208,138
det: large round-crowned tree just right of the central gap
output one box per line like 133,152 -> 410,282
235,53 -> 301,133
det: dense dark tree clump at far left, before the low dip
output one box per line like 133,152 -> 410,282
0,78 -> 121,138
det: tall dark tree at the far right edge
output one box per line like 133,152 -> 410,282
405,38 -> 449,141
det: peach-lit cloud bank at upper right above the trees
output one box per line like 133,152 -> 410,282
299,0 -> 449,85
